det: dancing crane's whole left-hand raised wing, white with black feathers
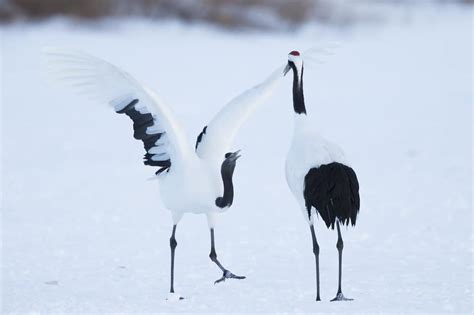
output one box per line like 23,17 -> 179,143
43,48 -> 192,174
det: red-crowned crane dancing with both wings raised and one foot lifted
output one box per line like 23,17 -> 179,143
45,49 -> 288,300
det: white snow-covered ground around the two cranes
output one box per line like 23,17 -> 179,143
0,7 -> 473,313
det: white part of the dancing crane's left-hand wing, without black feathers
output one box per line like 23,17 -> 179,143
43,48 -> 192,164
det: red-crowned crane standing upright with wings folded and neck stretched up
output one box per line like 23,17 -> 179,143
286,51 -> 360,301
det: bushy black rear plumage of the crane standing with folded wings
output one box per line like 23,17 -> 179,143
304,162 -> 360,229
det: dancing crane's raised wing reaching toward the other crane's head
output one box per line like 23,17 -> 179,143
195,66 -> 287,159
